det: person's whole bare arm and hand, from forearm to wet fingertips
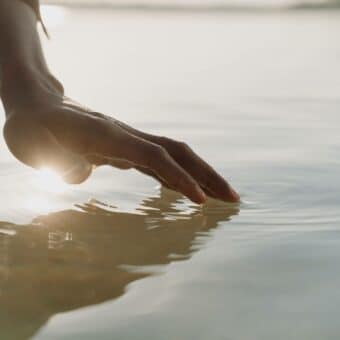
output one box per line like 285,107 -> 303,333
0,0 -> 239,204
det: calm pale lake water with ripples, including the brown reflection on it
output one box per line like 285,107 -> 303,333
0,8 -> 340,340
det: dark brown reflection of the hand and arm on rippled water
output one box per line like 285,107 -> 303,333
0,189 -> 238,340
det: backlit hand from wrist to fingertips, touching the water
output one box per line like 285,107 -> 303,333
4,89 -> 239,203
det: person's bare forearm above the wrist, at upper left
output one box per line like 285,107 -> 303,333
0,0 -> 60,112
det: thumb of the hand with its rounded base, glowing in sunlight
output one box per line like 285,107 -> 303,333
4,116 -> 92,184
